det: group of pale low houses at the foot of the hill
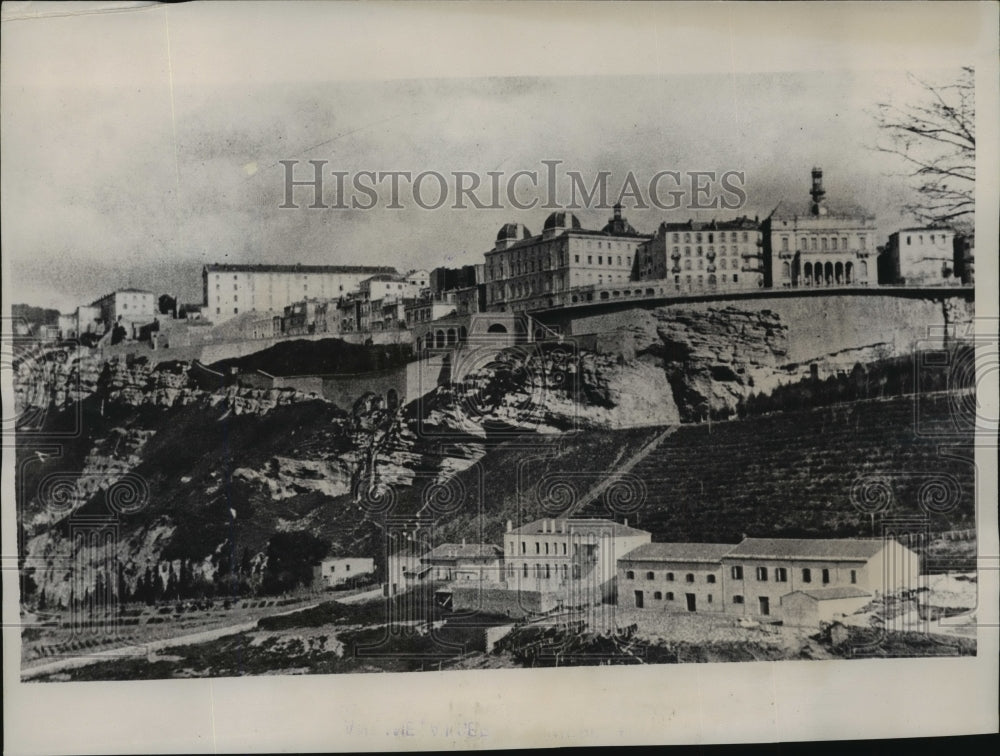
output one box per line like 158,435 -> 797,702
316,518 -> 920,625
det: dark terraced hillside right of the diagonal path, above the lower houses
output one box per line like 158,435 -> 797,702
587,393 -> 975,543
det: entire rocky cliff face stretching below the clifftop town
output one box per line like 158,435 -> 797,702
14,290 -> 972,605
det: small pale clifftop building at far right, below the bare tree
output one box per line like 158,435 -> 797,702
878,226 -> 961,286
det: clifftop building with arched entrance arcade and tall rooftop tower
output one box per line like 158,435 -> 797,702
761,168 -> 877,288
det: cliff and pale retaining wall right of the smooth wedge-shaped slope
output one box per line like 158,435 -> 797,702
574,296 -> 975,421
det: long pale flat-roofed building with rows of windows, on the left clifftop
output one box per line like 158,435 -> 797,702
202,263 -> 398,323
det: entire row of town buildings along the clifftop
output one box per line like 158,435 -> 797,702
43,168 -> 974,346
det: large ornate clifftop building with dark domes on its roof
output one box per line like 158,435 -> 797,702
485,204 -> 650,312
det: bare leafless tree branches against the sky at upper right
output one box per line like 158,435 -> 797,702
875,67 -> 976,232
